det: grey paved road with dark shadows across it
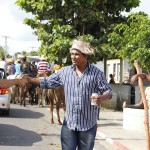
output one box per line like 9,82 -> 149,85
0,104 -> 115,150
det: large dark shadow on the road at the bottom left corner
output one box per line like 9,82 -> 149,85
0,124 -> 42,146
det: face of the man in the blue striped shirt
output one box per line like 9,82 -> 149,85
70,49 -> 87,66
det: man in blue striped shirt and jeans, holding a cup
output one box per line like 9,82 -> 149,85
23,40 -> 112,150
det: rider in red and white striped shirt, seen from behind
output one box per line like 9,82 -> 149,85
37,55 -> 49,73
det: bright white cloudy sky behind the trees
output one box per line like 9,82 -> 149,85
0,0 -> 150,55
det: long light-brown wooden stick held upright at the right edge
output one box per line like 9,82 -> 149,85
134,61 -> 150,150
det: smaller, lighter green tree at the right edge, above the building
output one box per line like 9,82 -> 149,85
109,12 -> 150,72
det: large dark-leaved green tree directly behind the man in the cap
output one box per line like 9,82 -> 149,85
16,0 -> 140,64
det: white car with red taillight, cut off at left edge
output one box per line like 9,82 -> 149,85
0,68 -> 11,115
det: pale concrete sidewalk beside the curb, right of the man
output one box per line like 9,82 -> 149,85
97,110 -> 147,150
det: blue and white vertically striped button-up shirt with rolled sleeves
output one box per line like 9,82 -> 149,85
40,64 -> 112,131
